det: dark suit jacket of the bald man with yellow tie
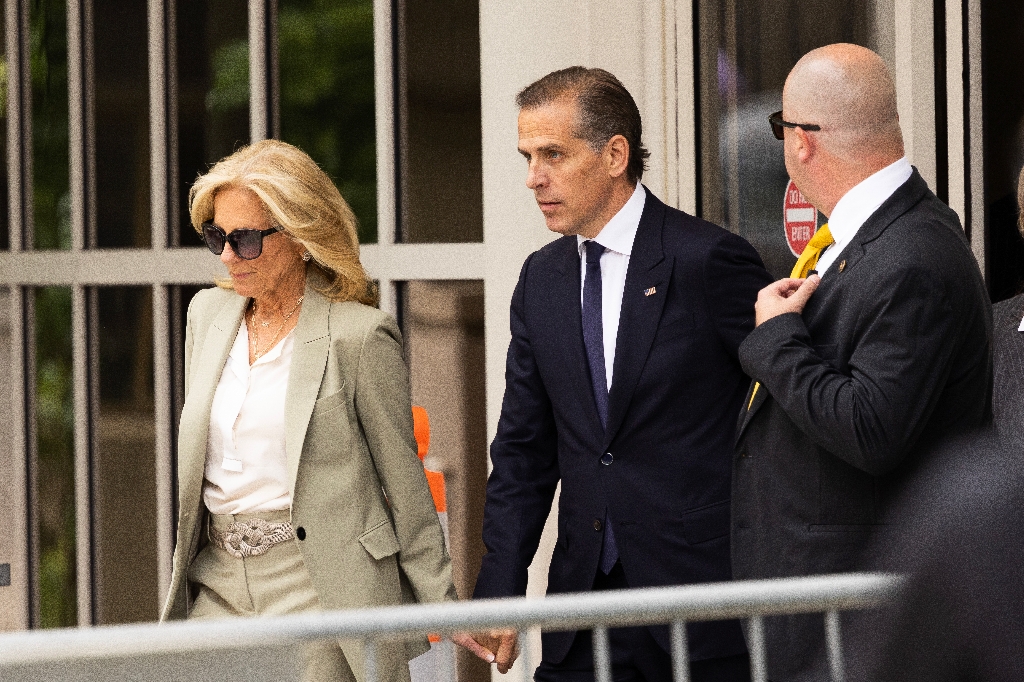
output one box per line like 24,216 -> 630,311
732,166 -> 992,682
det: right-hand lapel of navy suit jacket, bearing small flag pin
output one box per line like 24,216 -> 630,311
605,192 -> 675,444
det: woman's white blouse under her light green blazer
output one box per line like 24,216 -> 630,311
203,319 -> 295,514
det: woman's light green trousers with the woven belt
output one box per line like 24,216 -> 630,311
188,510 -> 355,682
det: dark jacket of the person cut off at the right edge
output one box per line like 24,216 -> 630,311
992,294 -> 1024,439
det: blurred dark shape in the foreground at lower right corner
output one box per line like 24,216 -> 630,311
844,430 -> 1024,682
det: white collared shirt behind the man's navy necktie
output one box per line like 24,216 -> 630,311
577,182 -> 647,391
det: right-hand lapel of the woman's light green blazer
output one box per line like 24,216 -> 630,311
285,272 -> 331,500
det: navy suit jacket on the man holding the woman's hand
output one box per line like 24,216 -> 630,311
475,190 -> 770,663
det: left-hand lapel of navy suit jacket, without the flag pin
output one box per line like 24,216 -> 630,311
547,237 -> 601,433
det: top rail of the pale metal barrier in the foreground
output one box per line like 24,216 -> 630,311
0,573 -> 901,667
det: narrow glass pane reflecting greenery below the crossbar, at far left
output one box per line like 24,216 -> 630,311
34,287 -> 78,628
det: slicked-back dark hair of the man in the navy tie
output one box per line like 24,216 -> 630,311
515,67 -> 650,182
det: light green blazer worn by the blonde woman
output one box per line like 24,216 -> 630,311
161,271 -> 456,680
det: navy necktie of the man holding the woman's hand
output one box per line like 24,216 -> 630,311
583,241 -> 618,574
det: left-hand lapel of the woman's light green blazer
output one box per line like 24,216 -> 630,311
178,296 -> 249,516
